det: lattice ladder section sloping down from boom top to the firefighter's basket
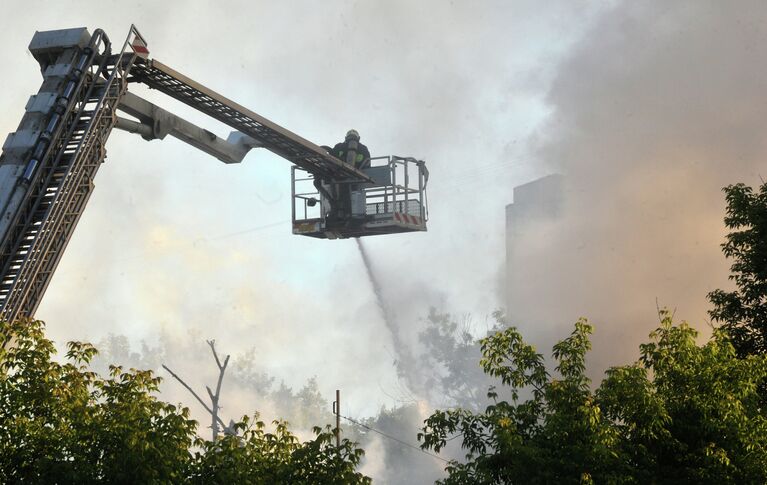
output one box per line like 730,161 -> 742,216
128,59 -> 371,182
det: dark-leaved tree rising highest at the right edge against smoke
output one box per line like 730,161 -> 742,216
708,183 -> 767,356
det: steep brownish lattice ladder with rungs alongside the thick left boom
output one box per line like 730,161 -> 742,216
0,28 -> 140,320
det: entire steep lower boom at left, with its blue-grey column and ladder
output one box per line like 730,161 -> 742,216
0,27 -> 143,320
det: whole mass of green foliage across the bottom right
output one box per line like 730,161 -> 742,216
419,312 -> 767,484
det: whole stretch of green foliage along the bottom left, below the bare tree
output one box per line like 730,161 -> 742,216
0,320 -> 369,484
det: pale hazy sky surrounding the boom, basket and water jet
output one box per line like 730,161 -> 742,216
0,1 -> 602,420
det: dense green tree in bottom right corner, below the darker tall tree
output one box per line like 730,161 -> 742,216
597,312 -> 767,483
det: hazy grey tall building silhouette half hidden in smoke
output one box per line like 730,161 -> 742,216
506,174 -> 565,322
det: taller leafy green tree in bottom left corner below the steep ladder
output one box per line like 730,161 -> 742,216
0,320 -> 196,483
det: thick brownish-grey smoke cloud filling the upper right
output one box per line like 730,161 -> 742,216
510,1 -> 767,368
